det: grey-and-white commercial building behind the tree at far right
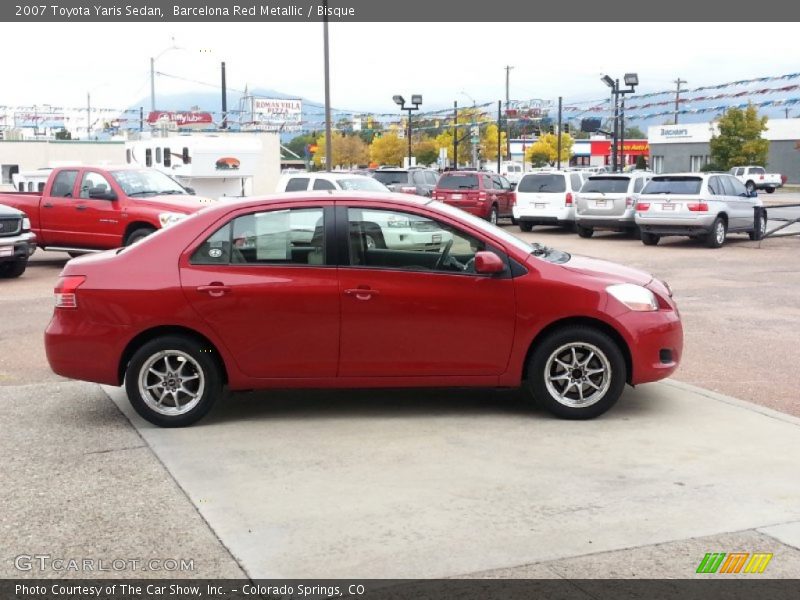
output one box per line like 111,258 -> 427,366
647,119 -> 800,183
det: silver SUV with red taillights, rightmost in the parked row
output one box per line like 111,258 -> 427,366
635,173 -> 767,248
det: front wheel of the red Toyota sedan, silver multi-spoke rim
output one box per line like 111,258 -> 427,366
526,325 -> 627,419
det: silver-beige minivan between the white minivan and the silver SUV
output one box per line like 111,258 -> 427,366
575,171 -> 652,238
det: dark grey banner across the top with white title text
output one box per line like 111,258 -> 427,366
0,0 -> 800,21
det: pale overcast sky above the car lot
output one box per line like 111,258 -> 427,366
0,23 -> 798,113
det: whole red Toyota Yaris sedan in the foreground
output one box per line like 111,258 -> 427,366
45,192 -> 683,427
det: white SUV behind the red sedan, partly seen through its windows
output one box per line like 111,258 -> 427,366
278,173 -> 451,251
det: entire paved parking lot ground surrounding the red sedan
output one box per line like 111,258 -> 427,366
0,193 -> 800,577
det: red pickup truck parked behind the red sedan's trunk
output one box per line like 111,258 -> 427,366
0,166 -> 211,256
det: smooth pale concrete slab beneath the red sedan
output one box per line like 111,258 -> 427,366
106,382 -> 800,578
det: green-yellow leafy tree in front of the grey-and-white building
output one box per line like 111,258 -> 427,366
710,104 -> 769,171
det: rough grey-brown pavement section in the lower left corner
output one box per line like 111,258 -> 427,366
0,382 -> 243,578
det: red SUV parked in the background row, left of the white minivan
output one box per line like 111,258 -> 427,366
433,171 -> 514,224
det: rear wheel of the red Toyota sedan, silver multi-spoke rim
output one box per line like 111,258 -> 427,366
125,335 -> 222,427
